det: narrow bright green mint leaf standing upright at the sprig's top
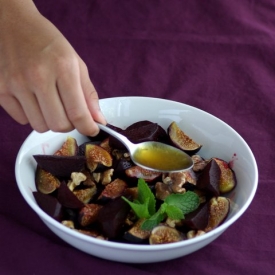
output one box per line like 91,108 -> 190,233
138,179 -> 156,215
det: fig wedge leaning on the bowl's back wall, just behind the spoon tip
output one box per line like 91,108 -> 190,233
168,121 -> 202,155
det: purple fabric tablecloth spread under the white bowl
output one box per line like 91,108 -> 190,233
0,0 -> 275,275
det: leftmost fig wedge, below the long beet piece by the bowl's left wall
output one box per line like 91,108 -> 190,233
35,166 -> 60,194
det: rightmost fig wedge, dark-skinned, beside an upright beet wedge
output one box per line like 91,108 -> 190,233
213,158 -> 237,194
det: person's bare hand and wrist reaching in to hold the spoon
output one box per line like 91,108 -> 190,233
0,0 -> 106,135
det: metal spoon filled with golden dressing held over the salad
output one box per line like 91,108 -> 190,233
98,123 -> 193,172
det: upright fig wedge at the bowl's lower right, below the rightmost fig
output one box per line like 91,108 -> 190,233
204,197 -> 230,232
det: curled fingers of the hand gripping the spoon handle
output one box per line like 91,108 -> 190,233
0,56 -> 106,136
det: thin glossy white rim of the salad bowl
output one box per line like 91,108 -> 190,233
15,96 -> 259,251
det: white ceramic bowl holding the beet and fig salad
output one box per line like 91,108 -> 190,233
15,97 -> 258,263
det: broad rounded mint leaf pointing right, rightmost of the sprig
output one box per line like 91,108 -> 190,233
165,191 -> 200,215
